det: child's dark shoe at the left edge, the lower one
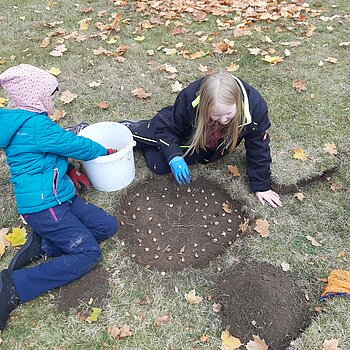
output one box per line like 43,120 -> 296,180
0,269 -> 19,331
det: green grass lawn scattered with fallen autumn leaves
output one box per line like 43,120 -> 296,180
0,0 -> 350,350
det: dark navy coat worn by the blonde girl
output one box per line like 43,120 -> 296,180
133,78 -> 271,192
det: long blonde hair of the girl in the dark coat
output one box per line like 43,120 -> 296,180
186,71 -> 244,154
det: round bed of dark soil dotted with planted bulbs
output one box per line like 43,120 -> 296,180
117,176 -> 242,271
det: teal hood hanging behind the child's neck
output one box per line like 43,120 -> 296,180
0,109 -> 36,148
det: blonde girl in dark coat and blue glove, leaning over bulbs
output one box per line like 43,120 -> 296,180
121,72 -> 282,207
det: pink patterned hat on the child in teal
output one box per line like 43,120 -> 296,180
0,64 -> 58,113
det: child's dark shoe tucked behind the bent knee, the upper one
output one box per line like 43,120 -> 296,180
9,231 -> 44,270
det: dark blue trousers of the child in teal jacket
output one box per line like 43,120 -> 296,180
13,196 -> 118,303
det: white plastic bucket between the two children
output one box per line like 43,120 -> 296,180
79,122 -> 135,192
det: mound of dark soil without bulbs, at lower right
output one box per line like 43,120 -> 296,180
216,262 -> 311,350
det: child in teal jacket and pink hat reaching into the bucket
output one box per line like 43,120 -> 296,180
0,64 -> 118,330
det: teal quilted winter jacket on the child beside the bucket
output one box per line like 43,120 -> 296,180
0,109 -> 107,214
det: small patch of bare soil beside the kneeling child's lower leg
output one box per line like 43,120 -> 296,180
57,266 -> 109,312
